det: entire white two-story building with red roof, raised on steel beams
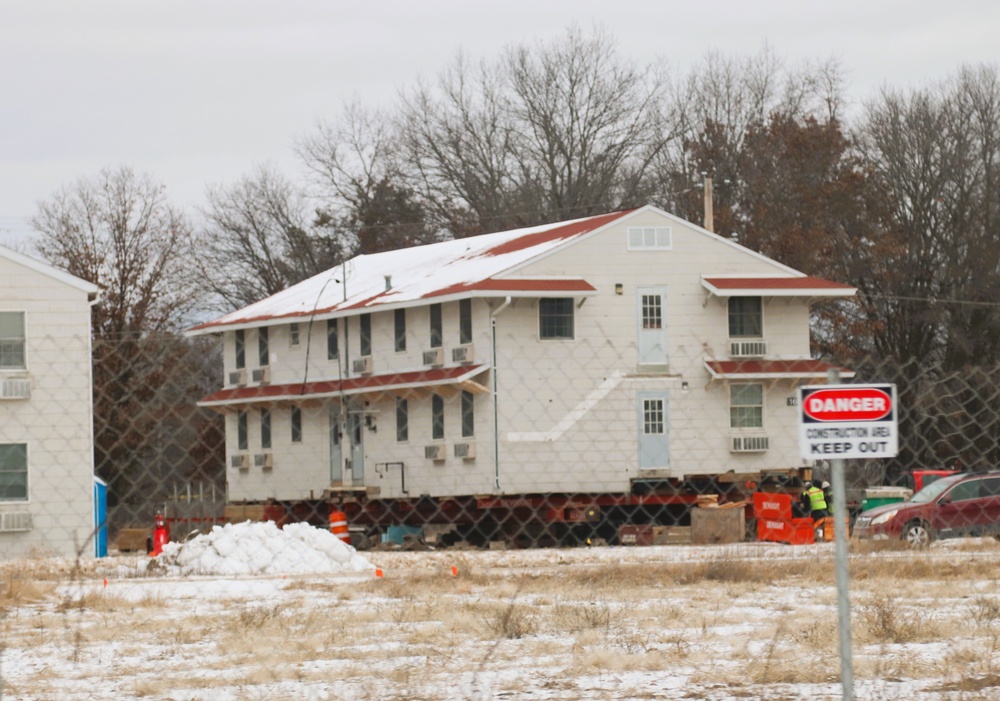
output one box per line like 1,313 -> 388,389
188,206 -> 855,500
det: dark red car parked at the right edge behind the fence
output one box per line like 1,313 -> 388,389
853,471 -> 1000,546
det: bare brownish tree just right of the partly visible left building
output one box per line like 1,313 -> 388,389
32,166 -> 224,520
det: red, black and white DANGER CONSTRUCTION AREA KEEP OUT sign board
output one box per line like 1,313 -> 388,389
799,385 -> 898,460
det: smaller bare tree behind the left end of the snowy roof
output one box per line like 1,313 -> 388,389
196,165 -> 344,309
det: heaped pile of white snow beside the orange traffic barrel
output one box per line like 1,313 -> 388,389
151,521 -> 375,576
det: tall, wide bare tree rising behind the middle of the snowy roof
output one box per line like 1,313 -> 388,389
401,28 -> 669,236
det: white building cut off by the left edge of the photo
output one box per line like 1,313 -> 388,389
0,247 -> 98,557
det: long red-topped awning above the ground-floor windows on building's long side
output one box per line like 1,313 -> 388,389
198,365 -> 489,411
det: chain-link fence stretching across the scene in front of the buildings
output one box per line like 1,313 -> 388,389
0,324 -> 1000,554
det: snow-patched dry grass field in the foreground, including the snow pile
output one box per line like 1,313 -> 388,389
0,524 -> 1000,701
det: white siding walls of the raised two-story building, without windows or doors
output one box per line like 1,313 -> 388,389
225,211 -> 809,500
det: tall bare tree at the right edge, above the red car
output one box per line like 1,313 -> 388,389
858,67 -> 1000,368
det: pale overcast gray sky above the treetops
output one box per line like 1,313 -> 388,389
0,0 -> 1000,245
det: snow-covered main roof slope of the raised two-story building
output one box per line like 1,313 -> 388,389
188,210 -> 635,335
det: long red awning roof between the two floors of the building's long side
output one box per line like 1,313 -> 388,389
198,365 -> 486,406
